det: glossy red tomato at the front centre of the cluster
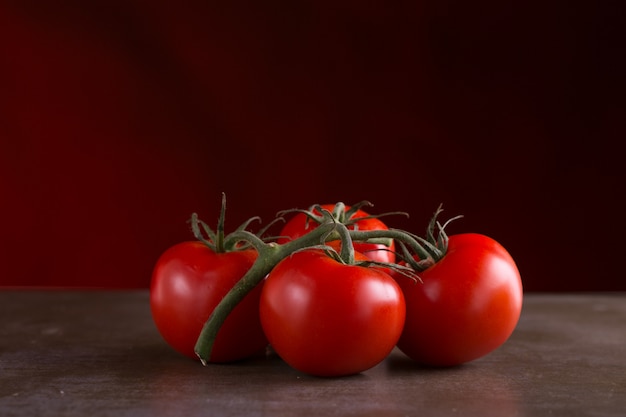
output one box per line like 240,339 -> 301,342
260,249 -> 405,376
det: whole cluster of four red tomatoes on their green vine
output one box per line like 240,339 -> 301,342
150,199 -> 522,377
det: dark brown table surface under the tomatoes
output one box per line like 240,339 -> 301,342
0,290 -> 626,417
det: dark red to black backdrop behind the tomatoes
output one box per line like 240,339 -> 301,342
0,0 -> 626,291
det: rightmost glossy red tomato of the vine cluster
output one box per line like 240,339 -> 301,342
394,233 -> 523,366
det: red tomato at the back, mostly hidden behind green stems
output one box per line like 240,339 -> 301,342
277,204 -> 396,263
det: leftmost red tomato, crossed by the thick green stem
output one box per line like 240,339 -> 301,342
150,242 -> 267,362
